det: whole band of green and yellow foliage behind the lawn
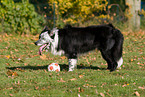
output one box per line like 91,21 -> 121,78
0,0 -> 145,34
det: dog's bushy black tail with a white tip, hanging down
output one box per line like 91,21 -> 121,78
112,29 -> 124,68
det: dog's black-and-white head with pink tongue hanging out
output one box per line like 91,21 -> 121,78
35,26 -> 58,55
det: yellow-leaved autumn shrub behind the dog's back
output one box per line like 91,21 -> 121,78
49,0 -> 108,26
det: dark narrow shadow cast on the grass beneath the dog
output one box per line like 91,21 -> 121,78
6,64 -> 107,71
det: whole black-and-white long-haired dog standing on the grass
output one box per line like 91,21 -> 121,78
35,24 -> 124,72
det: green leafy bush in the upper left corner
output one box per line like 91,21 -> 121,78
0,0 -> 45,34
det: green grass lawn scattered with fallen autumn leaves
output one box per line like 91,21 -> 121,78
0,31 -> 145,97
